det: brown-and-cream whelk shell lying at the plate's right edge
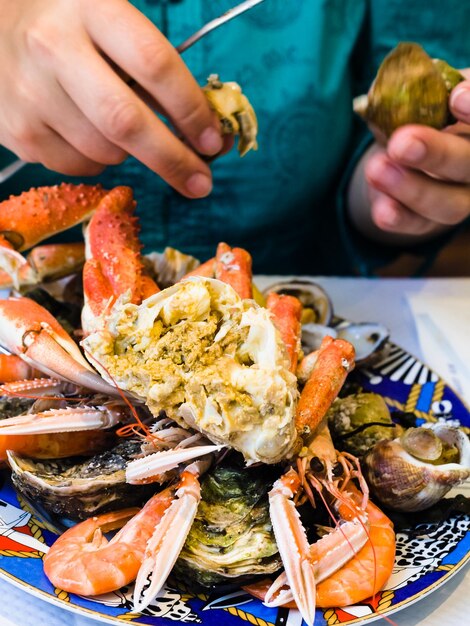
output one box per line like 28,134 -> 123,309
363,424 -> 470,511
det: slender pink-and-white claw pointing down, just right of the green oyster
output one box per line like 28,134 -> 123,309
269,469 -> 316,626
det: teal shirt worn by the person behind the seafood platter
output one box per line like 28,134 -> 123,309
0,0 -> 470,274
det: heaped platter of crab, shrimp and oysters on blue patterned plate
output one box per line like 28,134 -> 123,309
0,69 -> 470,626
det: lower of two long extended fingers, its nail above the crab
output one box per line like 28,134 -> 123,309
55,41 -> 212,198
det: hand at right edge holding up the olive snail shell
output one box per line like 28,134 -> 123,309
350,70 -> 470,244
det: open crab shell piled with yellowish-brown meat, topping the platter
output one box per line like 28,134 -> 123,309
83,277 -> 298,463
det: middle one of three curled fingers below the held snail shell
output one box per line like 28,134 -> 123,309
364,154 -> 470,225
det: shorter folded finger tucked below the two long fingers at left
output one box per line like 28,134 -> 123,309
38,79 -> 128,165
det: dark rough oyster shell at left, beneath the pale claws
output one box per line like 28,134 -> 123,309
8,440 -> 155,519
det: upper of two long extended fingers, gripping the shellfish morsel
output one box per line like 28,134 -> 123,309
84,0 -> 222,155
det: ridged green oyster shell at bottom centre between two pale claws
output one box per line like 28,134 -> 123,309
173,466 -> 282,587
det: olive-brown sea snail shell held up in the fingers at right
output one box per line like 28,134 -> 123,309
353,43 -> 463,138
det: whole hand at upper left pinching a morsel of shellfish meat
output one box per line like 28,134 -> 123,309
0,0 -> 223,198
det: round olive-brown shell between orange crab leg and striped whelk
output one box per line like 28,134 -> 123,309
327,393 -> 397,456
